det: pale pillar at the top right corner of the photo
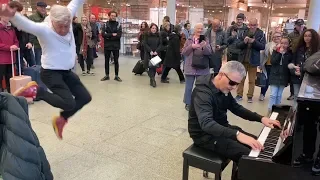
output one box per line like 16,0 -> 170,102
307,0 -> 320,32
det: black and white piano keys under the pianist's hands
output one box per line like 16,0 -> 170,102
249,112 -> 281,159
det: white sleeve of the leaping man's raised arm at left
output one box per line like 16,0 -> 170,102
10,13 -> 45,36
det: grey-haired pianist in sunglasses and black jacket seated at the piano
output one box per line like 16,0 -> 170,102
188,61 -> 280,163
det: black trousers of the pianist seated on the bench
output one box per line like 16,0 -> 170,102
196,125 -> 257,164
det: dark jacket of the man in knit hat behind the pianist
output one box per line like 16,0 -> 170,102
226,24 -> 248,54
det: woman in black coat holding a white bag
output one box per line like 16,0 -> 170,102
143,24 -> 162,87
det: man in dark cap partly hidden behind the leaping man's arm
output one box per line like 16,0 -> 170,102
29,1 -> 47,65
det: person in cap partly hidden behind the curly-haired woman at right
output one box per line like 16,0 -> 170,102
287,19 -> 307,100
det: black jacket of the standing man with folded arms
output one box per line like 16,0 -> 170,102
102,21 -> 122,50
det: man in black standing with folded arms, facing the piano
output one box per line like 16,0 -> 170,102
101,11 -> 122,82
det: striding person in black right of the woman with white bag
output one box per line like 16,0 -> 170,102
161,25 -> 185,83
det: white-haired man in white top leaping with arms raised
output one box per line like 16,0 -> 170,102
0,0 -> 91,139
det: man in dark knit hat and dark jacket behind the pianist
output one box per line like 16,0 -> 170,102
226,13 -> 248,61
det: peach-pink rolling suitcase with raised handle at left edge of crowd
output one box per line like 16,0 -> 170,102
10,49 -> 33,103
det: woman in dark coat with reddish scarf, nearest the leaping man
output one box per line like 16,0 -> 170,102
76,16 -> 95,76
